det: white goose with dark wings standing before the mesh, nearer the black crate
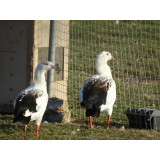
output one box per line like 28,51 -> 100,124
79,51 -> 116,128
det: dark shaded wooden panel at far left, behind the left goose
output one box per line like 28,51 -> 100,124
0,21 -> 28,105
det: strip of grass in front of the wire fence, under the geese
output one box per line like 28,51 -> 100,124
0,115 -> 160,140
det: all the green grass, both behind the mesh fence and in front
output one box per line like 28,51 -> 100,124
0,21 -> 160,140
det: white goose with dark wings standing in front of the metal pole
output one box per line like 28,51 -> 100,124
13,61 -> 55,138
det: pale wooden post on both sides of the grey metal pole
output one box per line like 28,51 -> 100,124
33,20 -> 69,100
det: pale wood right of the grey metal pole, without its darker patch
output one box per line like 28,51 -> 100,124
53,20 -> 69,100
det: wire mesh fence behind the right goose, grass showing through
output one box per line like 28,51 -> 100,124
68,20 -> 160,123
